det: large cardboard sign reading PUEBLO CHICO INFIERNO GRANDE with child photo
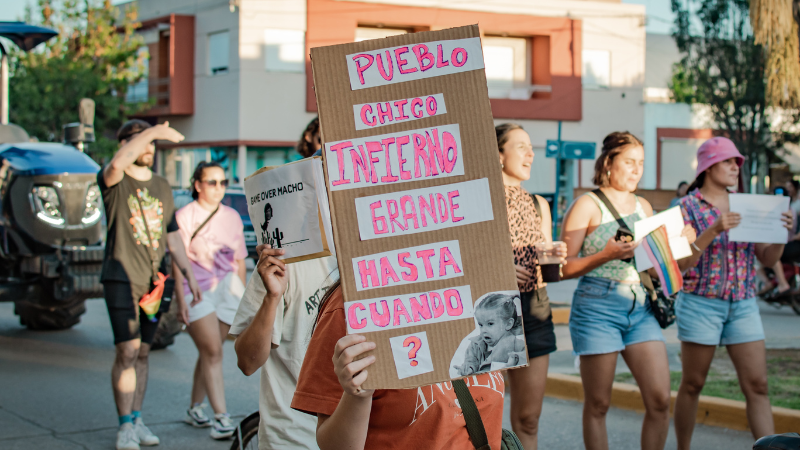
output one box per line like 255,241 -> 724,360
311,25 -> 527,389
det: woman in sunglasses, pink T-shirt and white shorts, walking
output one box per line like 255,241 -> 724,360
172,162 -> 247,439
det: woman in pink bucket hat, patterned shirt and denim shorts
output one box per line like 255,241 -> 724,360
675,137 -> 793,450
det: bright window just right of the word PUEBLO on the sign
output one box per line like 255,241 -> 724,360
482,36 -> 532,100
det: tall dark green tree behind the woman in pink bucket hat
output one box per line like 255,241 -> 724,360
670,0 -> 797,191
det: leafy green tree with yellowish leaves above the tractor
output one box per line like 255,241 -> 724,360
9,0 -> 145,161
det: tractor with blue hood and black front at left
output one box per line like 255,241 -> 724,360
0,99 -> 105,330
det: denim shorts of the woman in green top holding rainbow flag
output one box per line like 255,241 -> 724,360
569,277 -> 665,355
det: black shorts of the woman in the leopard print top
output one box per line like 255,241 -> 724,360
520,288 -> 556,358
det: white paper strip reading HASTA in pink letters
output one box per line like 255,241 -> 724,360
353,241 -> 464,291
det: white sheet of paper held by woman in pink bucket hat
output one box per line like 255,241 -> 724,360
728,194 -> 789,244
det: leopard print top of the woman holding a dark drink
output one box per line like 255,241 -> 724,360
505,186 -> 545,292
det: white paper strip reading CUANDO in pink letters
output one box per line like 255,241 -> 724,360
344,286 -> 475,334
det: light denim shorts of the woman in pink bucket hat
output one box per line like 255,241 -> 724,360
675,292 -> 764,345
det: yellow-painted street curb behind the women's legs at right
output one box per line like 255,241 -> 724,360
545,373 -> 800,434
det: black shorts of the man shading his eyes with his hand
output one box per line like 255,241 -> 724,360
103,281 -> 161,345
